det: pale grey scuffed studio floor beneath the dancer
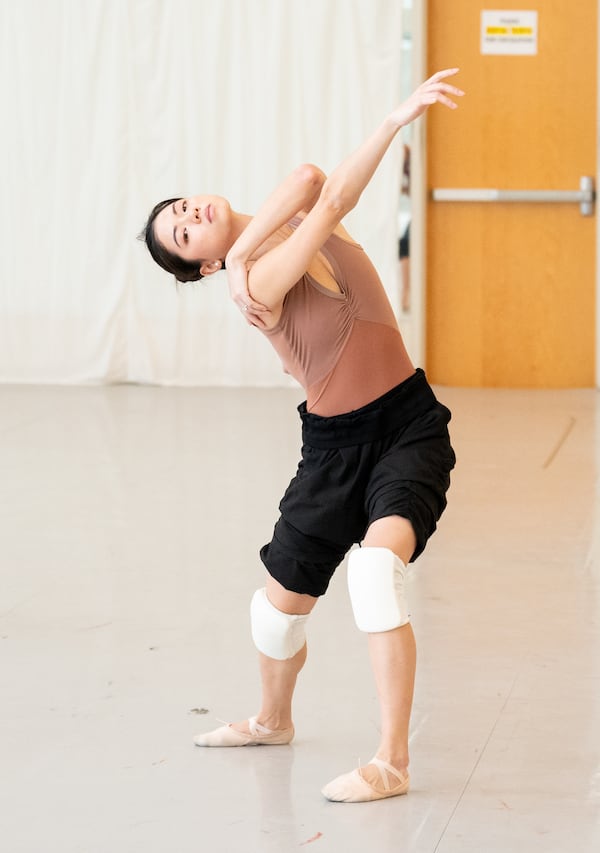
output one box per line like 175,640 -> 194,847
0,385 -> 600,853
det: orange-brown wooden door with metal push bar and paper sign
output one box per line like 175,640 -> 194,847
426,0 -> 597,388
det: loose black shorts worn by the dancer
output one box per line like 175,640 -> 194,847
260,369 -> 456,596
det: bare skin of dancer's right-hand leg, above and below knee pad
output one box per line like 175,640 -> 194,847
361,516 -> 416,788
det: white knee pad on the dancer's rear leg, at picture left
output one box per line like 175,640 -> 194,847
250,587 -> 310,660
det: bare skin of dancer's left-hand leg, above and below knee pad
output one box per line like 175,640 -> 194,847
233,575 -> 318,733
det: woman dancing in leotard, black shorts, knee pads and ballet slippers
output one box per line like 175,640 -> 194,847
144,68 -> 463,802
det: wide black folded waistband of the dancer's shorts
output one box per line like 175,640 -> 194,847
298,367 -> 437,450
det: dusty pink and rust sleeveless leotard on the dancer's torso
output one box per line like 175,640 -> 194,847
262,219 -> 415,417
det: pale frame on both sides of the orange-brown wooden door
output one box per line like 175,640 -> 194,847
410,0 -> 600,389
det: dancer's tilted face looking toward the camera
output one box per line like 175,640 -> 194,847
154,195 -> 232,271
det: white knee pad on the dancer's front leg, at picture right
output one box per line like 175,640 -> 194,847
348,548 -> 410,634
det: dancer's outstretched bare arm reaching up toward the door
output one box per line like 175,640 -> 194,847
244,68 -> 464,310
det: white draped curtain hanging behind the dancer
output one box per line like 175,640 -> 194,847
0,0 -> 408,385
